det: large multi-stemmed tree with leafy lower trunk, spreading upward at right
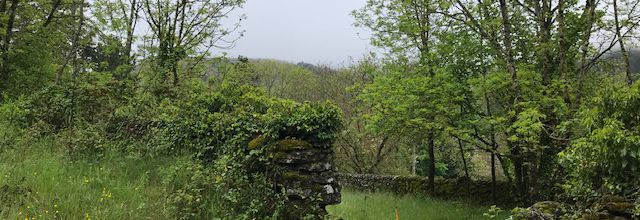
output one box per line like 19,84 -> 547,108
442,0 -> 634,202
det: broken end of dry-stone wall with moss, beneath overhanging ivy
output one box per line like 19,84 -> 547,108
249,137 -> 341,219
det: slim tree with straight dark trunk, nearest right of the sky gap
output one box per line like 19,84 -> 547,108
353,0 -> 448,193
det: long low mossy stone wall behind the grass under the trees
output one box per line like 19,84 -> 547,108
338,174 -> 514,207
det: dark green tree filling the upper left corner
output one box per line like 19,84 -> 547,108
0,0 -> 90,94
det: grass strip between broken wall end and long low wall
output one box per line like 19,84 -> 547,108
327,191 -> 508,220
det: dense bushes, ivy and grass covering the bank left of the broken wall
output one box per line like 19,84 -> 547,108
0,72 -> 340,219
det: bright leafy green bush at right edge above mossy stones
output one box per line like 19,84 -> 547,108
559,83 -> 640,201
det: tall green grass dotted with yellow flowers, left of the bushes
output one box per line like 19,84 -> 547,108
0,139 -> 189,219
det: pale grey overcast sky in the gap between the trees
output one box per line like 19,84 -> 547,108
219,0 -> 372,65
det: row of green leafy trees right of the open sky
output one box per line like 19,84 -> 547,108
342,0 -> 640,210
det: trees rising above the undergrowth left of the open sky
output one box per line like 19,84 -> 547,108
0,0 -> 244,96
